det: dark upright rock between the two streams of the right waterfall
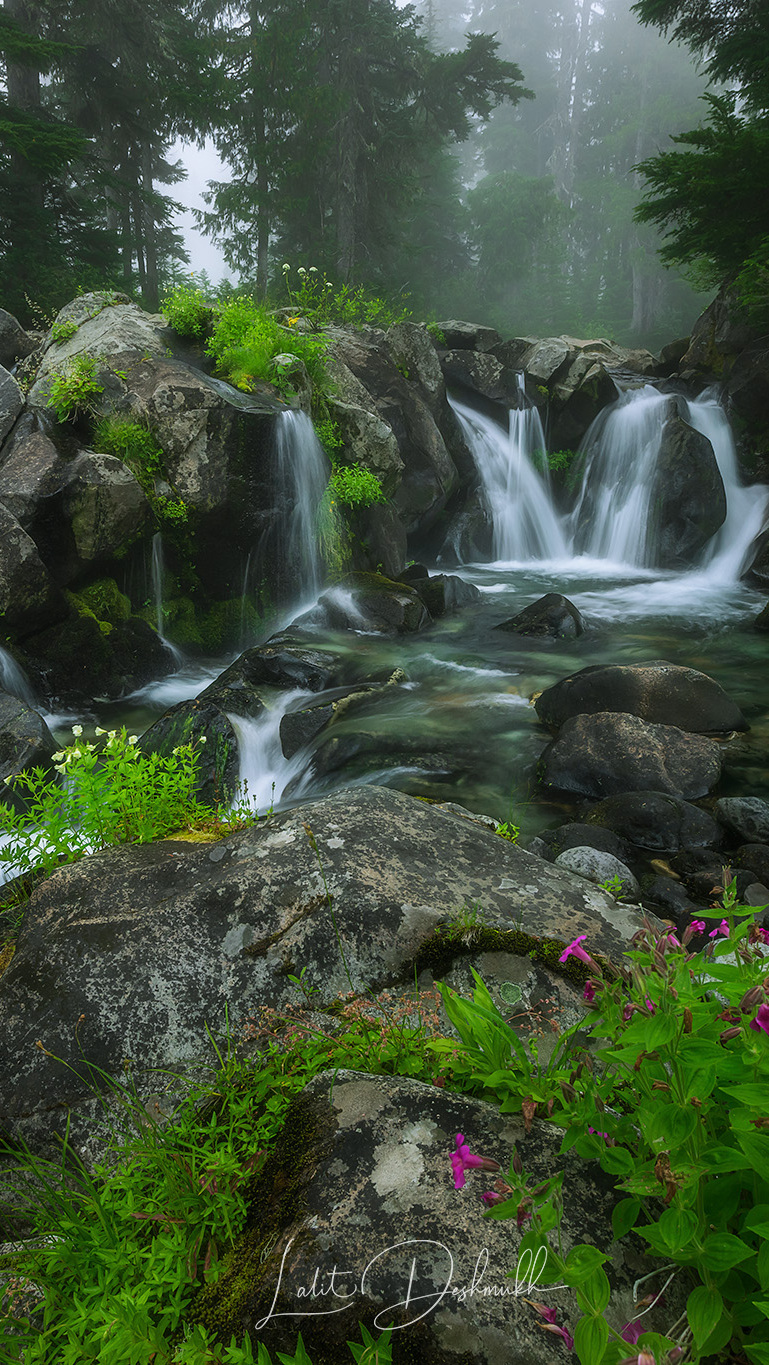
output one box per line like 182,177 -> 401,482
649,414 -> 727,568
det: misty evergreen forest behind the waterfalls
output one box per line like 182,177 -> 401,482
0,0 -> 769,348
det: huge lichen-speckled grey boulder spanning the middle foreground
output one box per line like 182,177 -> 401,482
0,786 -> 650,1147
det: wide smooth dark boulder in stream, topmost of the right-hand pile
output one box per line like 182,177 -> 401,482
535,659 -> 749,734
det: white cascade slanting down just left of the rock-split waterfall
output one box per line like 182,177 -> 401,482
449,375 -> 567,562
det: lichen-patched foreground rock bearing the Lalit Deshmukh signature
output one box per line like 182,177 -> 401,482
193,1070 -> 684,1365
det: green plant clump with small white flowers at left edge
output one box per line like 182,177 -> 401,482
0,725 -> 213,875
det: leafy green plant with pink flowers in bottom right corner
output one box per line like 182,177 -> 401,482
442,882 -> 769,1365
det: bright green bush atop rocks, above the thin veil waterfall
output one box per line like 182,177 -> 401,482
206,295 -> 328,393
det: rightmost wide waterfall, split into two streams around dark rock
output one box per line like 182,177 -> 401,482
570,385 -> 766,581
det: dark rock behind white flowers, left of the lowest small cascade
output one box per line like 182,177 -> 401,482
139,698 -> 240,807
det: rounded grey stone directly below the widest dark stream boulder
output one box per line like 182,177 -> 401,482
537,711 -> 721,800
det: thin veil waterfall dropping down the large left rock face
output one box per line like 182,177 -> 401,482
273,408 -> 331,599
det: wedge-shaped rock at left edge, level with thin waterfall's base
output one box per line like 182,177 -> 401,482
0,504 -> 67,639
